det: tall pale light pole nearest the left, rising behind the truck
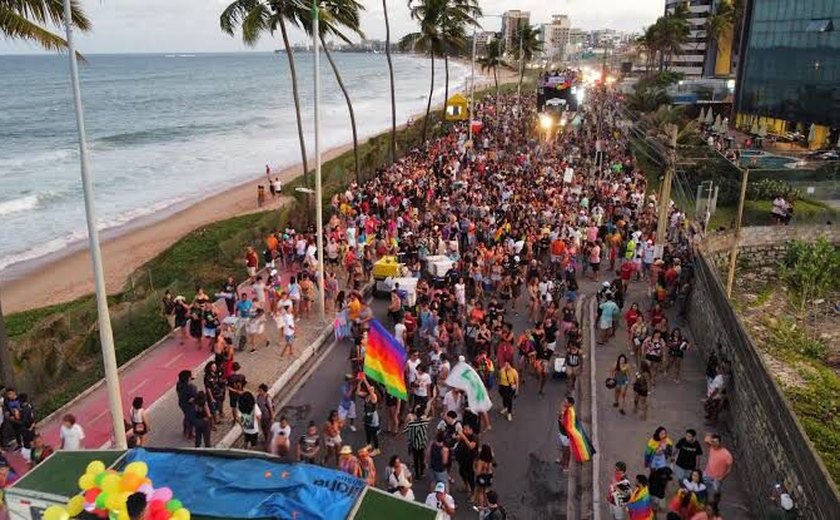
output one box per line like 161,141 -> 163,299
64,0 -> 127,450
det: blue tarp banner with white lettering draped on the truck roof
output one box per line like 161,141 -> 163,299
124,449 -> 365,520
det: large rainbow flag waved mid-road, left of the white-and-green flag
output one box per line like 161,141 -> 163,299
365,319 -> 408,401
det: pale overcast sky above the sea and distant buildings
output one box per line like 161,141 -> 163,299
0,0 -> 664,54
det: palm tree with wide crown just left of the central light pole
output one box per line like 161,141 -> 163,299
219,0 -> 310,186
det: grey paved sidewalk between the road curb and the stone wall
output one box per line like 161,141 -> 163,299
585,281 -> 752,520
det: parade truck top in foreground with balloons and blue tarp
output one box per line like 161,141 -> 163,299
5,448 -> 442,520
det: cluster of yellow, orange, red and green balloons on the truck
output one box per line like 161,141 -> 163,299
42,460 -> 190,520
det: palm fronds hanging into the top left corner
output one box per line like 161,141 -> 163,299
0,0 -> 91,51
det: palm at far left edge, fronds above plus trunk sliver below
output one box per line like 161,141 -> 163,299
0,0 -> 91,386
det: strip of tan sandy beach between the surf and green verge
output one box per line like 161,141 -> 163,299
0,67 -> 518,313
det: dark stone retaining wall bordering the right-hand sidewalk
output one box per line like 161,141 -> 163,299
688,226 -> 840,520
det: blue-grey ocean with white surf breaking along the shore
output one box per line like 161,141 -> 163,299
0,53 -> 469,274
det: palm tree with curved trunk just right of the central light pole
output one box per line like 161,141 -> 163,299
299,0 -> 364,183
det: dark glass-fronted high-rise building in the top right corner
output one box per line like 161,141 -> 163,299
735,0 -> 840,148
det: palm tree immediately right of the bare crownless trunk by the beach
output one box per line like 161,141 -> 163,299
400,0 -> 448,142
